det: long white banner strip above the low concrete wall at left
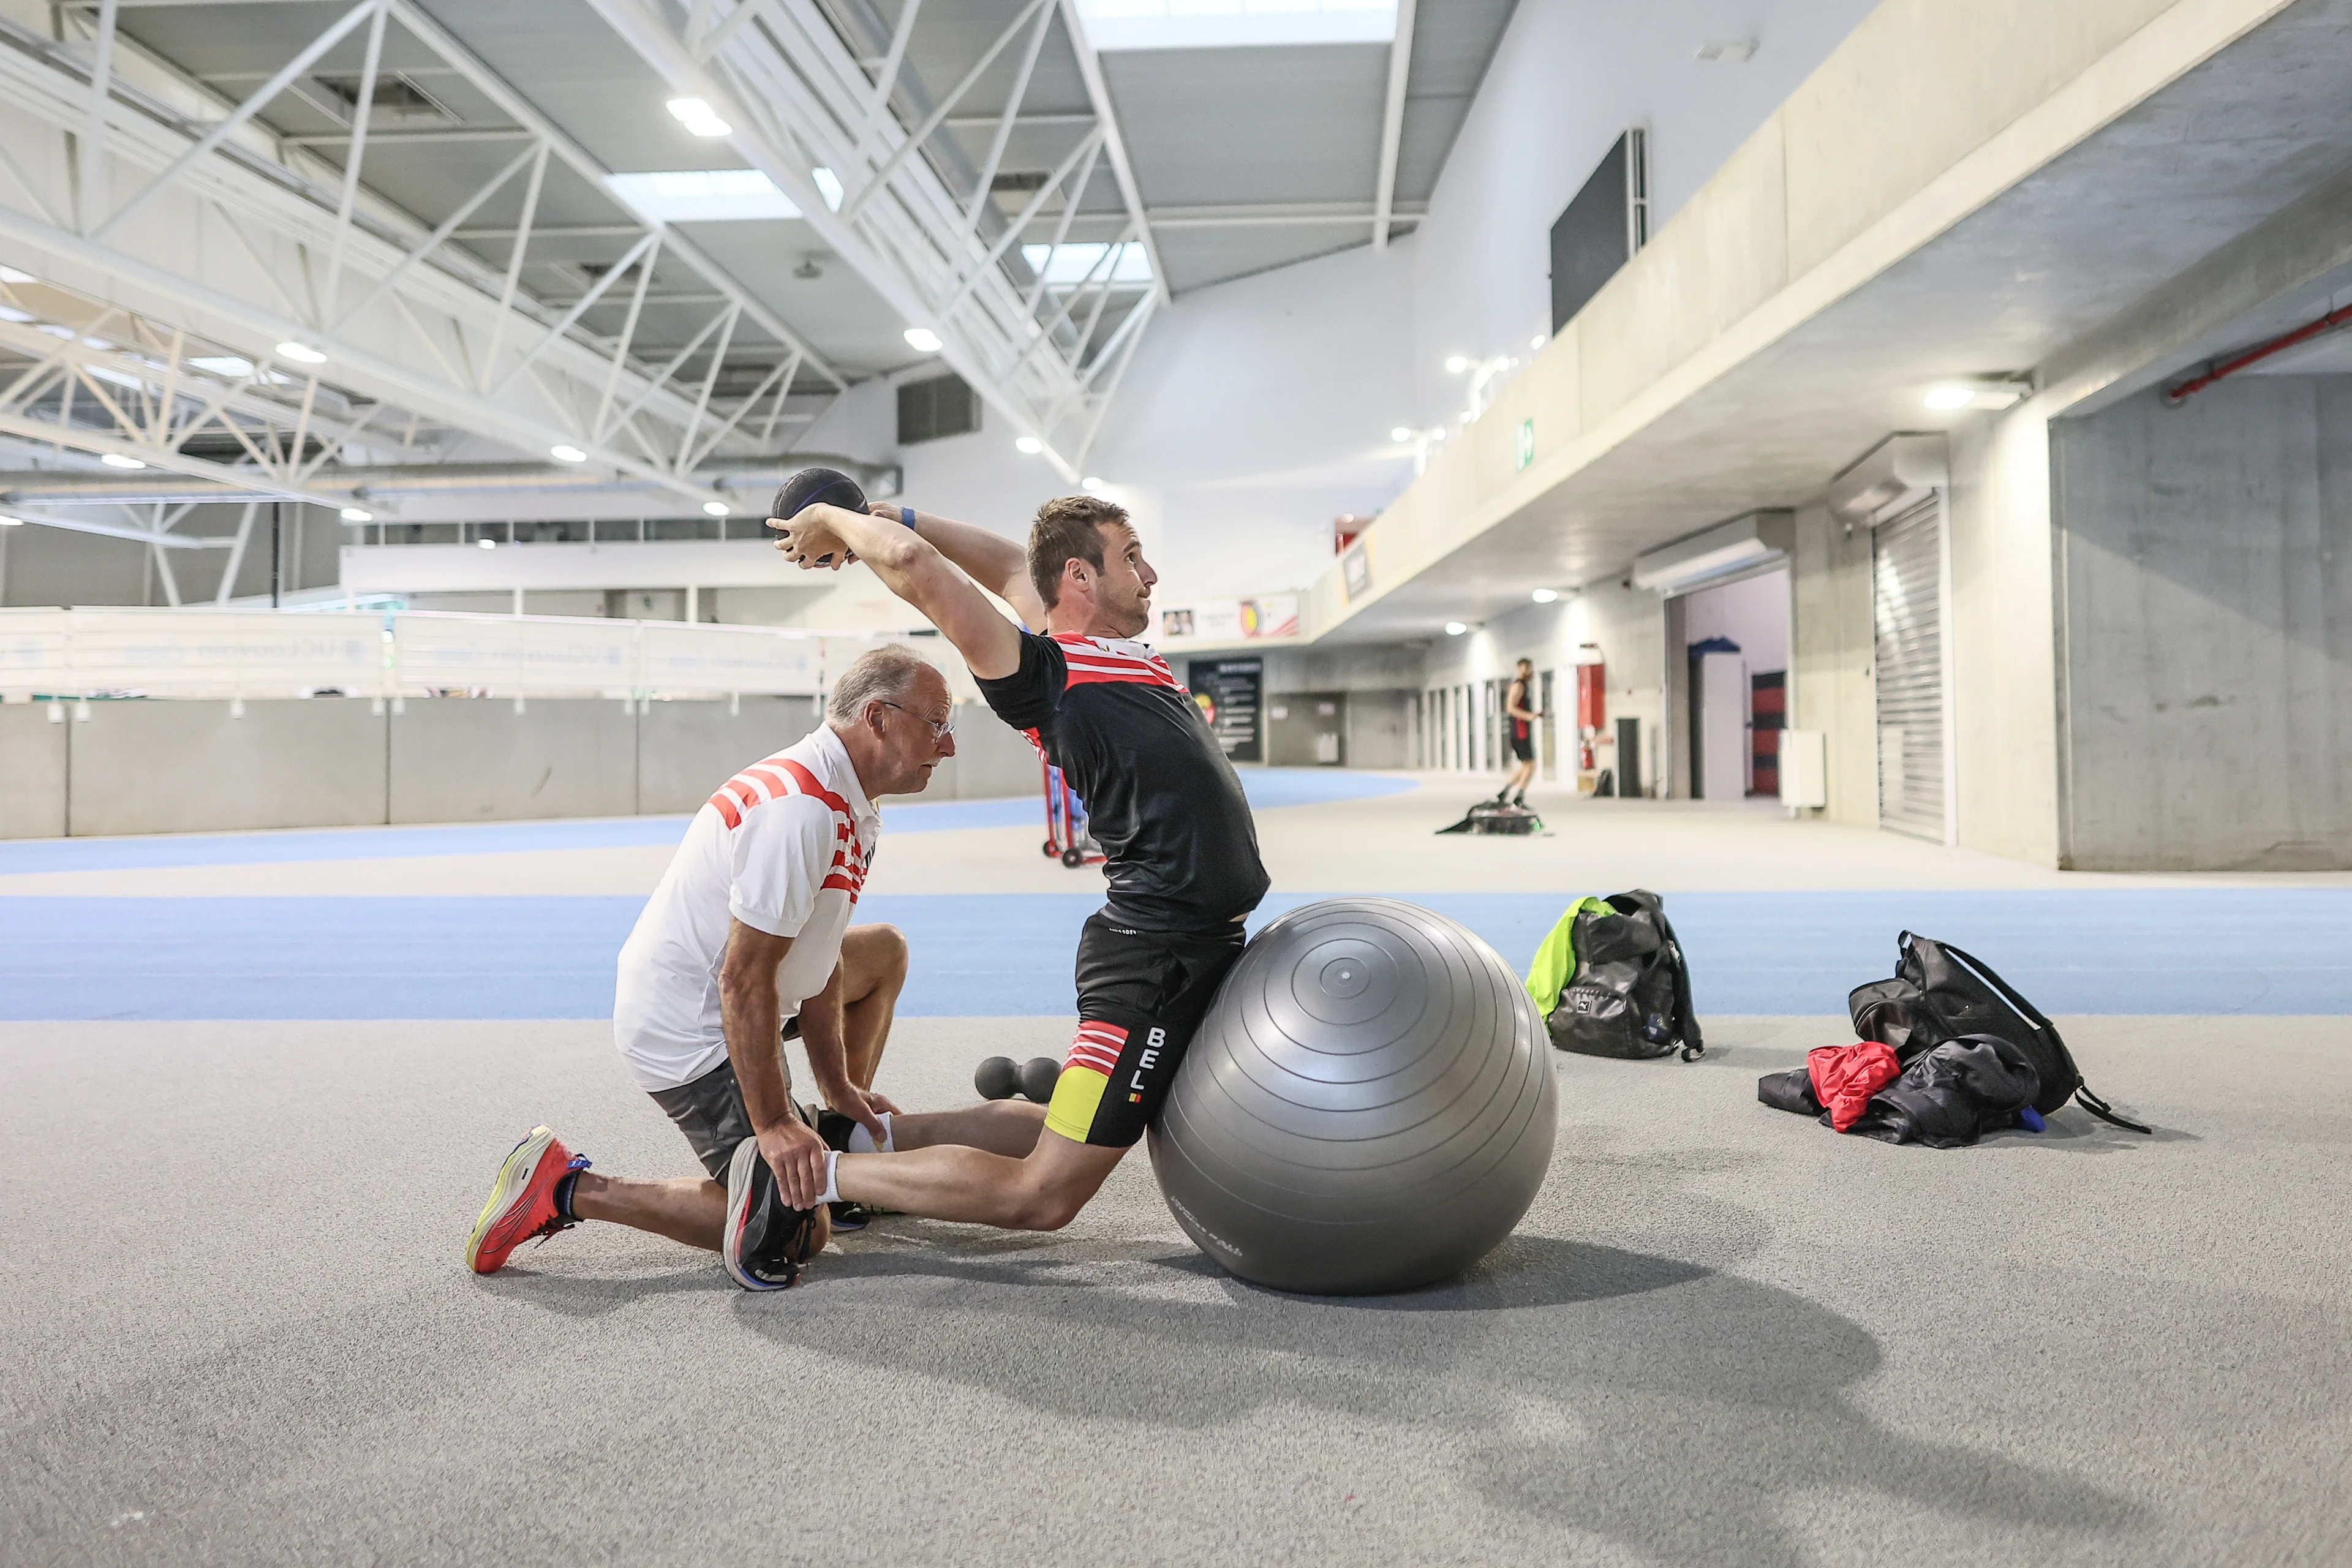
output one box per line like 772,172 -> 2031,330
0,609 -> 922,703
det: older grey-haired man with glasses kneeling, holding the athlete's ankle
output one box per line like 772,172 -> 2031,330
466,646 -> 1044,1291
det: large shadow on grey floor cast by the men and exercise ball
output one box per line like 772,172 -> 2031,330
736,1220 -> 2138,1568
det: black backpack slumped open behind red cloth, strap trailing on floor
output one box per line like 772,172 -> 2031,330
1846,931 -> 2150,1133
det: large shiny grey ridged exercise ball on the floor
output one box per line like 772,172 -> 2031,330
1150,898 -> 1559,1295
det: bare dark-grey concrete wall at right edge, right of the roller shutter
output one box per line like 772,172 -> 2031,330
2051,376 -> 2352,872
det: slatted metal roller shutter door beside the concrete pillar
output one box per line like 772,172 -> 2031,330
1870,494 -> 1945,844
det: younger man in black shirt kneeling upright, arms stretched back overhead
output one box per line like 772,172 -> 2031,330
769,496 -> 1268,1229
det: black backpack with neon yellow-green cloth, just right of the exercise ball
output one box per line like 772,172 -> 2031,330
1536,889 -> 1708,1063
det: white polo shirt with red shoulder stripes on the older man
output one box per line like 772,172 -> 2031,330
611,724 -> 882,1091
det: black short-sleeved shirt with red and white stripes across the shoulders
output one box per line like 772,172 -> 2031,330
981,632 -> 1268,931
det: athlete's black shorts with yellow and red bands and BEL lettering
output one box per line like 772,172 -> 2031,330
1044,914 -> 1244,1150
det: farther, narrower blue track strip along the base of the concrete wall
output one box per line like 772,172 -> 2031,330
0,769 -> 1414,875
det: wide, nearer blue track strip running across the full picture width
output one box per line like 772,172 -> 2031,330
0,889 -> 2352,1020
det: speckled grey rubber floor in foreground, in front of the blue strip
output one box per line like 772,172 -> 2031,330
0,1018 -> 2352,1566
